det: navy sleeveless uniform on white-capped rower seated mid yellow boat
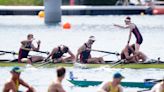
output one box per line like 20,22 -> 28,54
80,43 -> 91,63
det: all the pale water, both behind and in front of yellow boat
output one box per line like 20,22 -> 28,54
0,15 -> 164,92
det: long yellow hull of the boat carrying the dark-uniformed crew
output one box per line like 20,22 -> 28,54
0,60 -> 164,69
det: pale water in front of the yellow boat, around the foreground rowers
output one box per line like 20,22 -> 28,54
0,67 -> 164,92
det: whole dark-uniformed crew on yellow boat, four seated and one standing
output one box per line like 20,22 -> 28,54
18,17 -> 147,64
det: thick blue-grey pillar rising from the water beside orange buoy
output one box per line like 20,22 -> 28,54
44,0 -> 62,24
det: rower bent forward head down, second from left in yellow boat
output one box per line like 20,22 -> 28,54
46,45 -> 75,63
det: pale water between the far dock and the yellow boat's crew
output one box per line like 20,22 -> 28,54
0,15 -> 164,59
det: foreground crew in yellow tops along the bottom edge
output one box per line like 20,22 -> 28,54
2,66 -> 164,92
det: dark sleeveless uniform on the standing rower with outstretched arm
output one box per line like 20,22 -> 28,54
132,25 -> 143,45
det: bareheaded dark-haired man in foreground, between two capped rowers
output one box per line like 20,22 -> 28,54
47,67 -> 66,92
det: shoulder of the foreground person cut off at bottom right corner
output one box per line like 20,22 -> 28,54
150,78 -> 164,92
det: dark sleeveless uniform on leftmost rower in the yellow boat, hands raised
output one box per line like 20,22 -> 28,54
18,43 -> 32,62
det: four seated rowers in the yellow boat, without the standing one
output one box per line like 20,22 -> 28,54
18,34 -> 147,64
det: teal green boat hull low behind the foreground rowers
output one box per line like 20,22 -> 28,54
68,79 -> 155,88
